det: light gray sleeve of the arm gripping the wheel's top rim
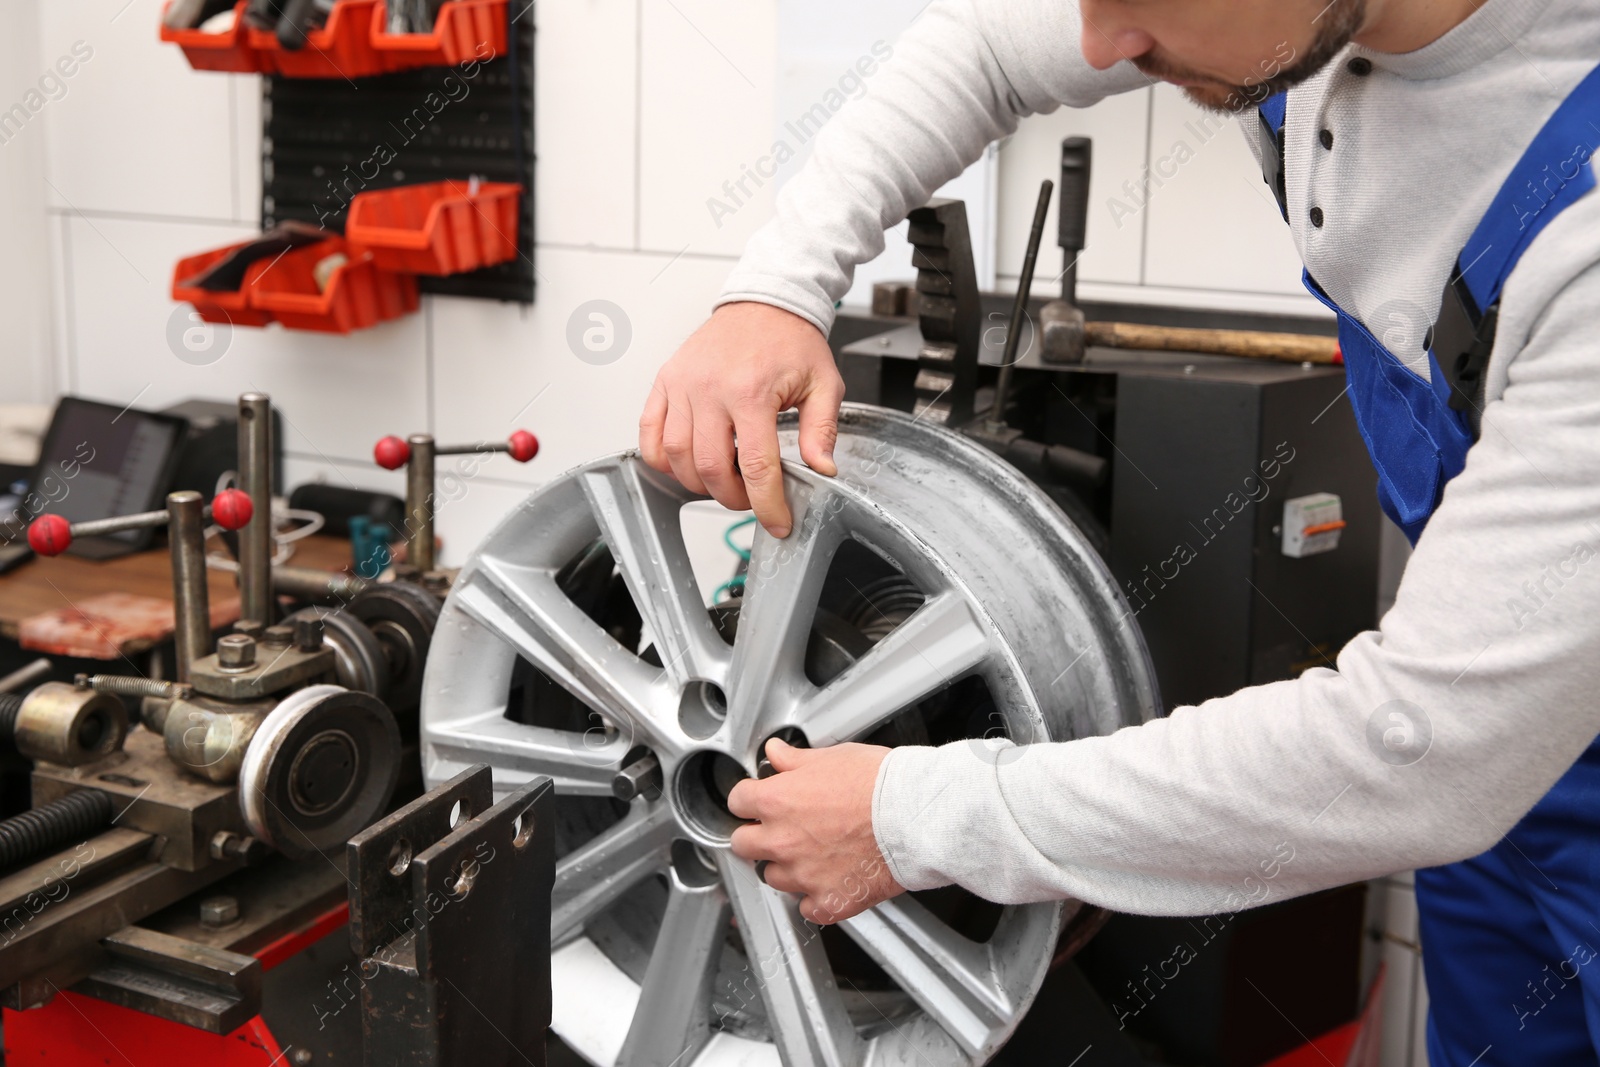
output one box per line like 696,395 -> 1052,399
718,0 -> 1147,333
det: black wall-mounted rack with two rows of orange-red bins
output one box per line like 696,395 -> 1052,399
160,0 -> 534,333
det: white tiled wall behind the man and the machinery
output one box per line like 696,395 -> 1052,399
0,0 -> 1307,560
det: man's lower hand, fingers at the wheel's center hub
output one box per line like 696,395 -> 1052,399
728,739 -> 906,926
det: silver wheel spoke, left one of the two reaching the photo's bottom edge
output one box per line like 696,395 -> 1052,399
616,872 -> 728,1067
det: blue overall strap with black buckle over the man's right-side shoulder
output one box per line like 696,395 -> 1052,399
1427,66 -> 1600,422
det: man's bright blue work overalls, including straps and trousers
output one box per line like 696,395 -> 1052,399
1259,67 -> 1600,1067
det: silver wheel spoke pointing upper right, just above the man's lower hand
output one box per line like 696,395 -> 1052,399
795,592 -> 992,747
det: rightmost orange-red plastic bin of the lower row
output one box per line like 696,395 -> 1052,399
344,181 -> 522,275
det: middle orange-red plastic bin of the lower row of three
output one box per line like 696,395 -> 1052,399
245,237 -> 418,333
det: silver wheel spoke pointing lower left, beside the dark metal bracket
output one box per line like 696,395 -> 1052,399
550,801 -> 675,947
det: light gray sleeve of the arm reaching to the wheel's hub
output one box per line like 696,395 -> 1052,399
874,212 -> 1600,915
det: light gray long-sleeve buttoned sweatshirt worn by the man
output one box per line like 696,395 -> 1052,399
722,0 -> 1600,913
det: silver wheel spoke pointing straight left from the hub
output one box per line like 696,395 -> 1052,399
429,709 -> 632,797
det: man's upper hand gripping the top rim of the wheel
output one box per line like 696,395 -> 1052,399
638,302 -> 845,537
